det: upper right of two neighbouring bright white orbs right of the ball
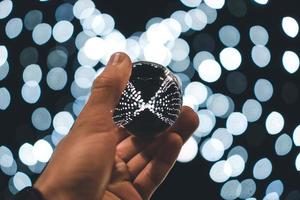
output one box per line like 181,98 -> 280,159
220,47 -> 242,71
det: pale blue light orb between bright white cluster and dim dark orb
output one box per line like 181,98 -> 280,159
171,38 -> 190,61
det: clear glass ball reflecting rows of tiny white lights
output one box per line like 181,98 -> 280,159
113,61 -> 182,137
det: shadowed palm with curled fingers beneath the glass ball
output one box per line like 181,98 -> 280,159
104,125 -> 191,200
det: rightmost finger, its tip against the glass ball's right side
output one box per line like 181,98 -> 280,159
134,107 -> 199,199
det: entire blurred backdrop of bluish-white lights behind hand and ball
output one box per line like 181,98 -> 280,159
0,0 -> 300,200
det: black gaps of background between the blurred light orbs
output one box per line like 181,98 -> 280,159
0,0 -> 300,200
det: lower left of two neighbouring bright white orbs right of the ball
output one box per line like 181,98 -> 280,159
198,59 -> 222,83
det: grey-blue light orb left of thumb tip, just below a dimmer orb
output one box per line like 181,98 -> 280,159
46,67 -> 68,91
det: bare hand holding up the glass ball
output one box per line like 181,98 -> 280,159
34,53 -> 199,200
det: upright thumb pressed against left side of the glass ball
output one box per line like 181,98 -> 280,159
79,52 -> 132,127
